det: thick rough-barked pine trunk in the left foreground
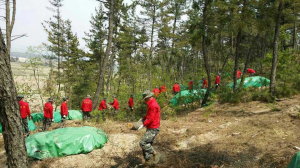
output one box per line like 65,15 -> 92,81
0,30 -> 28,168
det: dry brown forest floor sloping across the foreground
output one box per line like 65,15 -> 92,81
0,96 -> 300,168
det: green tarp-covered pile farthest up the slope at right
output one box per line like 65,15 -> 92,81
228,76 -> 270,88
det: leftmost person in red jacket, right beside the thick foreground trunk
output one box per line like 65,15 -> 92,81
17,95 -> 31,137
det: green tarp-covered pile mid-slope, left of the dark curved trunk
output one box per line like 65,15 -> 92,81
170,89 -> 206,106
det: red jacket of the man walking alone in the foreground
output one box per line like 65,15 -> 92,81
143,98 -> 160,129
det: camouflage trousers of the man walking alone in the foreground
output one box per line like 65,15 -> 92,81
140,128 -> 159,161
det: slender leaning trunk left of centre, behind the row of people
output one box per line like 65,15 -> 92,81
93,0 -> 114,110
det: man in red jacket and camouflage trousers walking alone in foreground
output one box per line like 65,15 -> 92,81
140,90 -> 160,164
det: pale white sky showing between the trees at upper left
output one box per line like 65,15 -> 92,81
6,0 -> 124,53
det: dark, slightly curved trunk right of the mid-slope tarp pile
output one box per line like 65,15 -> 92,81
202,0 -> 211,106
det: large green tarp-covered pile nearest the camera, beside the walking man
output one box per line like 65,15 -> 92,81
26,127 -> 108,160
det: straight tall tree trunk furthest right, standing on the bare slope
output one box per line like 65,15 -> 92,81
270,1 -> 283,96
